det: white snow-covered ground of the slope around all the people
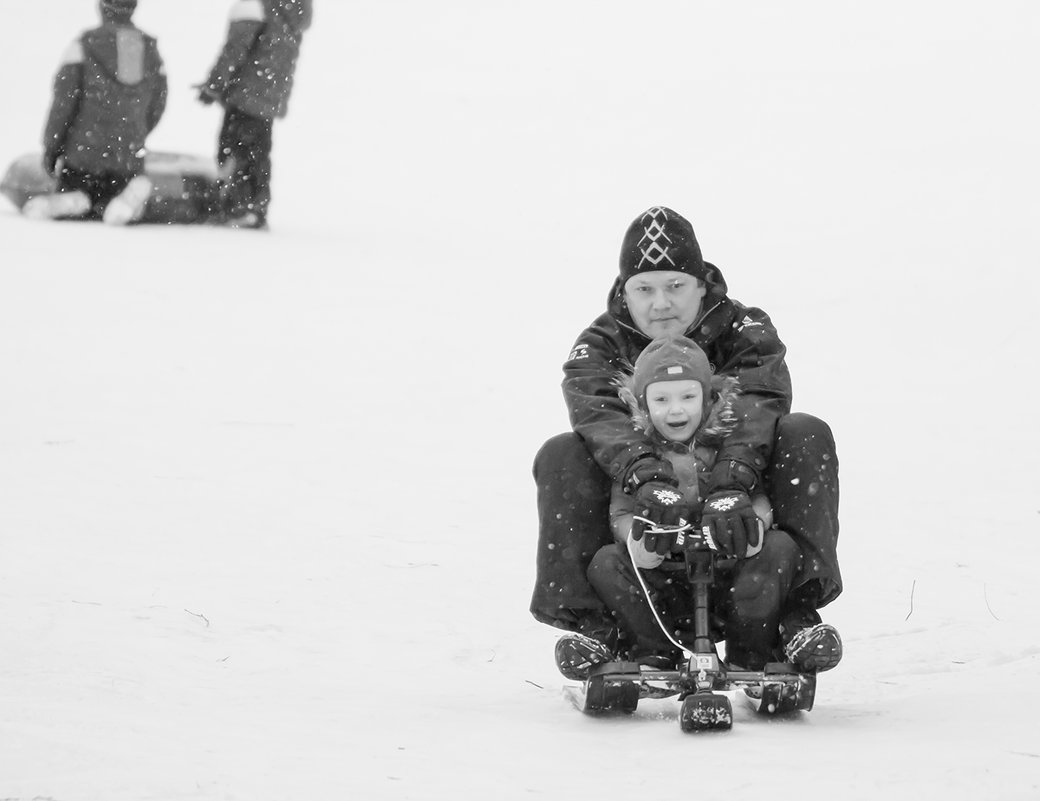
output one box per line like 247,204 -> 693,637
0,0 -> 1040,801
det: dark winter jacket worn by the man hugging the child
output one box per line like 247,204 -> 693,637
563,265 -> 791,490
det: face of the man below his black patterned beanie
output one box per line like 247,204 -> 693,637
625,269 -> 707,339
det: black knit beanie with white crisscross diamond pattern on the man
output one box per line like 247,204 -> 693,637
620,206 -> 714,285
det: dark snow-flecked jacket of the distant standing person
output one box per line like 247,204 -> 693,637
206,0 -> 311,120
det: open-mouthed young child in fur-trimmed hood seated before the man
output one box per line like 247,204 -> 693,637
556,337 -> 841,679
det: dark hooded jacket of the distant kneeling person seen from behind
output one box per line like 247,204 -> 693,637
44,22 -> 167,175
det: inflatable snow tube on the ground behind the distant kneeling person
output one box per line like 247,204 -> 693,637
0,152 -> 219,225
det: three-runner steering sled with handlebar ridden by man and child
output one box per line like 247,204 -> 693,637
579,525 -> 816,732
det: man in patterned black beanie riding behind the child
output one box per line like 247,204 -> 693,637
530,207 -> 841,675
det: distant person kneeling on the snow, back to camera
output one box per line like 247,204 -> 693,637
23,0 -> 167,225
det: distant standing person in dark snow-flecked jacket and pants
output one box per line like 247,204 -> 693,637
199,0 -> 311,228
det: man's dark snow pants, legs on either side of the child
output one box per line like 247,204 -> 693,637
530,413 -> 841,632
